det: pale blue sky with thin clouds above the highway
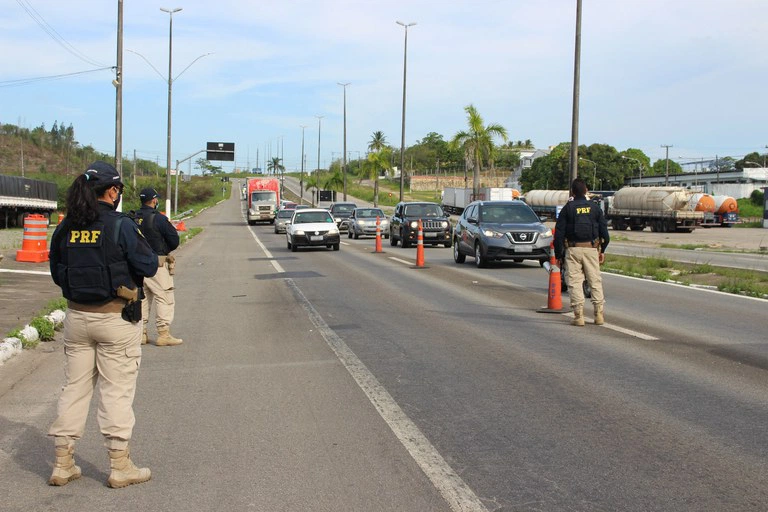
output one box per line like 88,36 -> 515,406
0,0 -> 768,174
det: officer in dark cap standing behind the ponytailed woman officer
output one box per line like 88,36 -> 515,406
136,188 -> 182,347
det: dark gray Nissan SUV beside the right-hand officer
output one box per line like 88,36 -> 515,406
453,200 -> 552,267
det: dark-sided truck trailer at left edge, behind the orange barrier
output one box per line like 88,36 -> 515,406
0,175 -> 58,228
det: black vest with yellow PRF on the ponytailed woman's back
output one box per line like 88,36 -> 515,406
54,213 -> 137,304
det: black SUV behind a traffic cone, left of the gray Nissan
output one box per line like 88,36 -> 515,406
389,202 -> 451,248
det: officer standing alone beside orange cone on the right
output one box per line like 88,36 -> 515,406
555,178 -> 610,326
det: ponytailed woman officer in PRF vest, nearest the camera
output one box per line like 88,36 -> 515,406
48,161 -> 157,487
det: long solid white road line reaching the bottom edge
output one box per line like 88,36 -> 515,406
285,278 -> 488,512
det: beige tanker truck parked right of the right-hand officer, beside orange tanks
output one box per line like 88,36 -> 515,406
606,187 -> 704,233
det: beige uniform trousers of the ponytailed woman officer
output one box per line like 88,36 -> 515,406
48,309 -> 141,450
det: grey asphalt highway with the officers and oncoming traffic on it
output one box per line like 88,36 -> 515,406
0,186 -> 768,511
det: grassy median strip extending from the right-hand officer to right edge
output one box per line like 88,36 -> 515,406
602,254 -> 768,298
